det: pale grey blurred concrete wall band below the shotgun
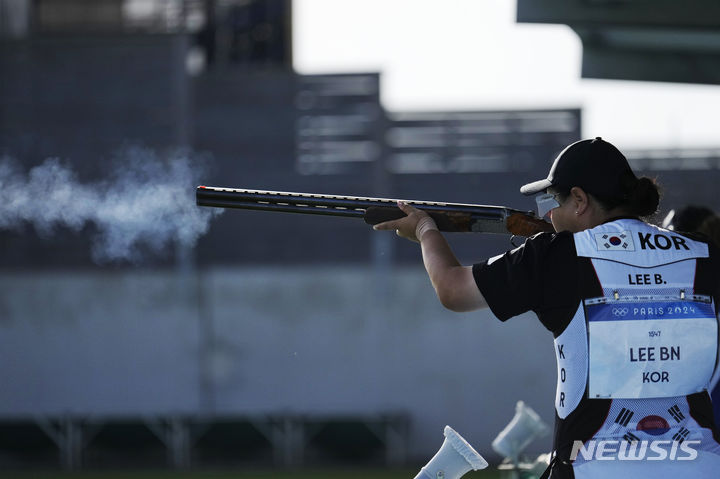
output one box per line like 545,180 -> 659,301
0,266 -> 556,459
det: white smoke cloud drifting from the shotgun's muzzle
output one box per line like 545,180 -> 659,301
0,147 -> 222,263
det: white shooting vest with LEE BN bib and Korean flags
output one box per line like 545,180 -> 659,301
555,219 -> 718,466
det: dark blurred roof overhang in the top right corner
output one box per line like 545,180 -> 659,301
517,0 -> 720,85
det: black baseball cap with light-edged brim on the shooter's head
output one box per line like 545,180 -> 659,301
520,137 -> 635,198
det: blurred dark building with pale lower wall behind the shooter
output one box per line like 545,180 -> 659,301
0,0 -> 720,469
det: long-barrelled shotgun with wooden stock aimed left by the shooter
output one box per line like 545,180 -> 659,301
195,186 -> 554,237
